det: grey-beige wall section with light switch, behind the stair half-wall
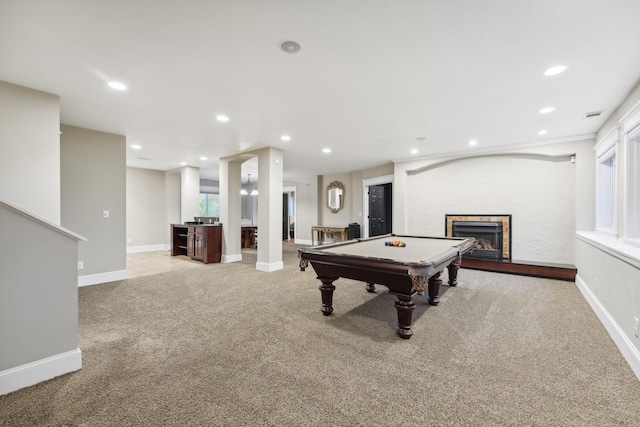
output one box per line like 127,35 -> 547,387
60,125 -> 127,276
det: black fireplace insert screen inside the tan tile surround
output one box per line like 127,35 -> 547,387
452,221 -> 502,260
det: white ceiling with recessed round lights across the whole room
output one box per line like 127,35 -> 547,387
0,0 -> 640,180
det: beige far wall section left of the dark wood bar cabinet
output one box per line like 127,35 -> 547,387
127,167 -> 169,249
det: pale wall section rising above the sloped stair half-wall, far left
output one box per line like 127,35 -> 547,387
0,82 -> 60,224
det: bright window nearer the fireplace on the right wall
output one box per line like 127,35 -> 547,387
593,127 -> 619,236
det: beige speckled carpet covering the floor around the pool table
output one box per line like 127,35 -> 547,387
0,244 -> 640,426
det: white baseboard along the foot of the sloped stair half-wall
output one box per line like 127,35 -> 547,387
0,348 -> 82,395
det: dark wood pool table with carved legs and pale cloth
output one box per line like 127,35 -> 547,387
298,234 -> 475,339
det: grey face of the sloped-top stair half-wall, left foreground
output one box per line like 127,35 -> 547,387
0,207 -> 78,374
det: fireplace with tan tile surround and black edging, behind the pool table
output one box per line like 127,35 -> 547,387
445,215 -> 511,261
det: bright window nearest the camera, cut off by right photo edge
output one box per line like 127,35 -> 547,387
619,102 -> 640,247
